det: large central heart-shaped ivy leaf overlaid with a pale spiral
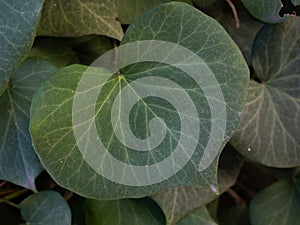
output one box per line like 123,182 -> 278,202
30,3 -> 248,199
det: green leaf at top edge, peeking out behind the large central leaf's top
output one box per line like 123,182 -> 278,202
116,0 -> 192,24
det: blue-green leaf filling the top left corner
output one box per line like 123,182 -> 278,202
0,0 -> 44,95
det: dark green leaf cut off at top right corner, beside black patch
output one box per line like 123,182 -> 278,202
242,0 -> 300,23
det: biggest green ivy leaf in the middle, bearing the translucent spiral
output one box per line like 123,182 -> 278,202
31,3 -> 249,199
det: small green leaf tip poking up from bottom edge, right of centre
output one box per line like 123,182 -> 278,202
176,207 -> 218,225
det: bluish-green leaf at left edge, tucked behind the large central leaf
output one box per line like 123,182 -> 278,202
0,59 -> 56,189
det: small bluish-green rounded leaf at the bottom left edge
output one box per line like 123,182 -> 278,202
19,191 -> 71,225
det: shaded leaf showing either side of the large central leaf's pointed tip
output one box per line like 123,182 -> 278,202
151,145 -> 243,225
